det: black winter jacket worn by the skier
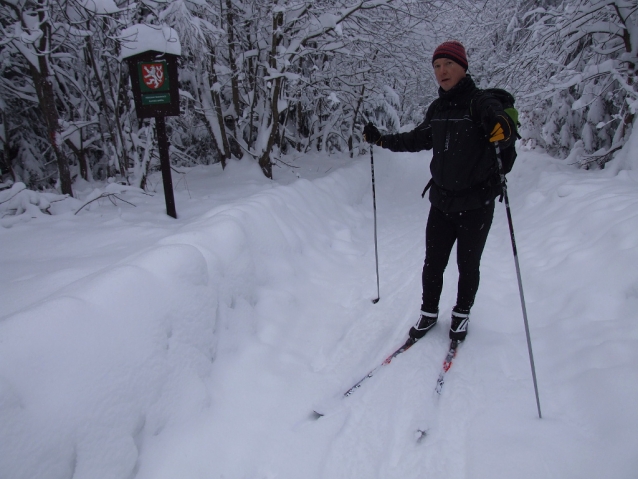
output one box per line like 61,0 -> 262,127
379,75 -> 516,212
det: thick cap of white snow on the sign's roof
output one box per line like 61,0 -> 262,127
120,24 -> 182,60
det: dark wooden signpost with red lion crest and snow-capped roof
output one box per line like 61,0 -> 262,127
122,25 -> 180,218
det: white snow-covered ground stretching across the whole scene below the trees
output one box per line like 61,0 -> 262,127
0,145 -> 638,479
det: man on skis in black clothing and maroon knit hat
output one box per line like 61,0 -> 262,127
363,41 -> 516,341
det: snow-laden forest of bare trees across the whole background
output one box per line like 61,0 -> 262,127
0,0 -> 638,196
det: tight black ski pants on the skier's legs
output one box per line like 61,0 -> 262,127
422,201 -> 494,313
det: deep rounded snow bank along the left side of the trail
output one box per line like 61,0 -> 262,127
0,162 -> 370,479
